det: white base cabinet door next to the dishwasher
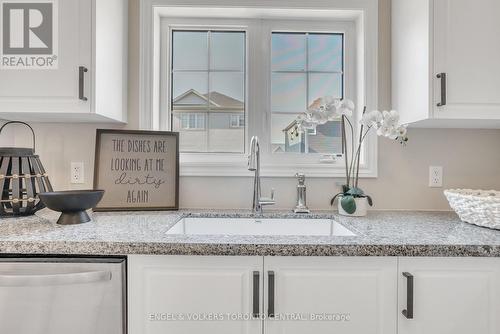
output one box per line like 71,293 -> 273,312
128,256 -> 262,334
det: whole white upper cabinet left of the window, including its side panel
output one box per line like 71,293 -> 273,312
0,0 -> 128,122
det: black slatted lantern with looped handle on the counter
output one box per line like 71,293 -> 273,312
0,121 -> 53,216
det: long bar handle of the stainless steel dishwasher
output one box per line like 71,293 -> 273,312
0,271 -> 112,287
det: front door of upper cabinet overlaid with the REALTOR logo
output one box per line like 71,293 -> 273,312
0,0 -> 92,113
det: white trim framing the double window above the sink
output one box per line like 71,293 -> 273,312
139,0 -> 378,177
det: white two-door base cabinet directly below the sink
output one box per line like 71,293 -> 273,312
128,256 -> 397,334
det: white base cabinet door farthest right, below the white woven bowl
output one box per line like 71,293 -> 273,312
399,258 -> 500,334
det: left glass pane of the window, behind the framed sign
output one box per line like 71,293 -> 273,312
170,29 -> 246,153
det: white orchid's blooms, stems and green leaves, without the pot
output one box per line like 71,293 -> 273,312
297,96 -> 408,214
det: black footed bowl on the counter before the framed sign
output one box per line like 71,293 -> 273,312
38,190 -> 104,225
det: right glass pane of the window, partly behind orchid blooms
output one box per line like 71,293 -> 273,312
271,32 -> 344,154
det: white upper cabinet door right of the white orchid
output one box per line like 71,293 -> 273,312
432,0 -> 500,119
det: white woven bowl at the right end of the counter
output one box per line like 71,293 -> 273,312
444,189 -> 500,230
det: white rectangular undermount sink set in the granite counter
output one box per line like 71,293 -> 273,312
167,217 -> 355,237
